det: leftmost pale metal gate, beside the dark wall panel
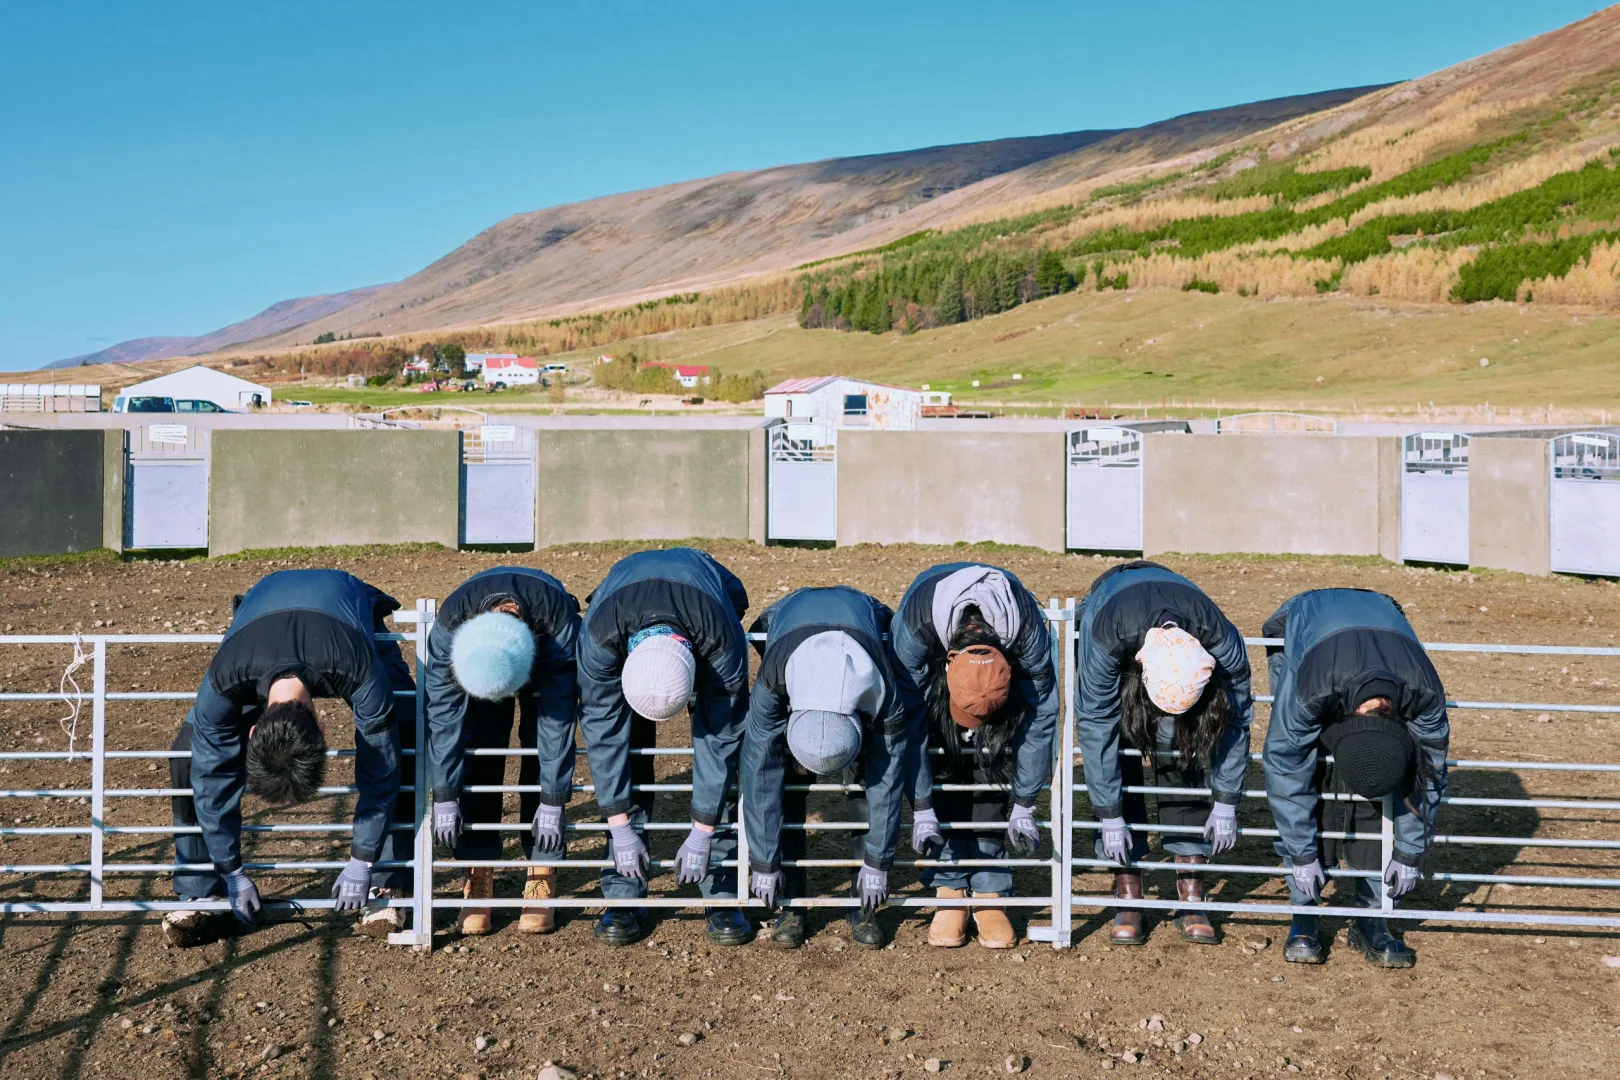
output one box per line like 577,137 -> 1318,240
123,423 -> 209,551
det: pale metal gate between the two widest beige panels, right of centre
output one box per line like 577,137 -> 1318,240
1068,427 -> 1142,551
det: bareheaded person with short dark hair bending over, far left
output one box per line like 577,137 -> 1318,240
164,570 -> 416,946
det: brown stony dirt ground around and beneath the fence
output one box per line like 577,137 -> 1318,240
0,542 -> 1620,1080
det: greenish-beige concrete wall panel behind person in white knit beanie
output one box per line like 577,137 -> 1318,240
535,427 -> 751,547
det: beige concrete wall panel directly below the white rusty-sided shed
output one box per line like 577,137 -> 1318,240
838,427 -> 1064,551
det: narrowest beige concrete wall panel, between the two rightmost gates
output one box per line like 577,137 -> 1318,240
1468,437 -> 1552,575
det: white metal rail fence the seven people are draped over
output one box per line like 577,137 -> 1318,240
0,599 -> 1620,947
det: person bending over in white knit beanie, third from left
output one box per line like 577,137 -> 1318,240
577,547 -> 753,946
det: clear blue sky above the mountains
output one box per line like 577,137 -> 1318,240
0,0 -> 1594,369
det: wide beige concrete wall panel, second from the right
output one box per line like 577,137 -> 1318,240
1142,434 -> 1400,557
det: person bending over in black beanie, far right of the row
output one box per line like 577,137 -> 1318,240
1262,589 -> 1452,968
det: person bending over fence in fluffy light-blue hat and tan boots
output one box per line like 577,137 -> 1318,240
426,567 -> 580,934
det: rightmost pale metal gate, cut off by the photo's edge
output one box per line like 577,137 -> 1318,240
1552,431 -> 1620,575
